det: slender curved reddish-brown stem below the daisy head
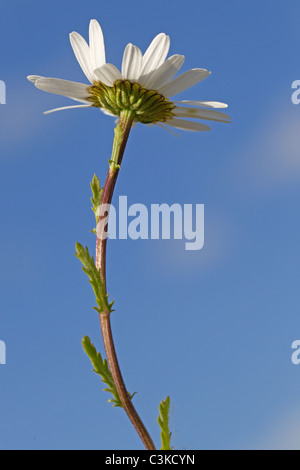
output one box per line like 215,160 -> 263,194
96,111 -> 155,450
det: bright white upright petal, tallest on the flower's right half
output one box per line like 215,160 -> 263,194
142,33 -> 170,76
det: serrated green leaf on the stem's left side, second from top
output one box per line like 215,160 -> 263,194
75,243 -> 113,314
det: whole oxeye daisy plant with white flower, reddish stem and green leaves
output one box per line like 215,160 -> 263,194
28,20 -> 230,450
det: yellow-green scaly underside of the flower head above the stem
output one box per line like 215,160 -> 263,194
88,80 -> 176,124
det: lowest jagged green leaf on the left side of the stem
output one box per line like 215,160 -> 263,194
82,336 -> 135,408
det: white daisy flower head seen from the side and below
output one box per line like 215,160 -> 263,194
27,20 -> 230,131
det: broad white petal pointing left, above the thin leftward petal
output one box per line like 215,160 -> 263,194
35,78 -> 90,100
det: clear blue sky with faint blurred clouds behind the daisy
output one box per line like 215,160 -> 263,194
0,0 -> 300,449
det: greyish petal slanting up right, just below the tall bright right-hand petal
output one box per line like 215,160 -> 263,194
143,54 -> 184,90
